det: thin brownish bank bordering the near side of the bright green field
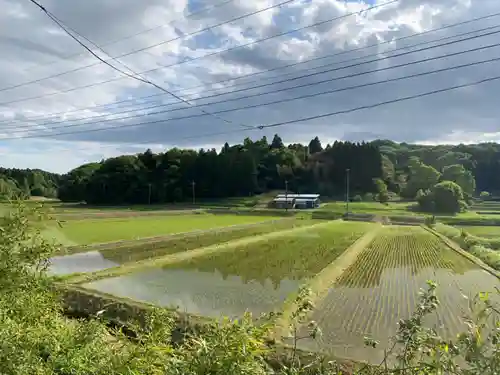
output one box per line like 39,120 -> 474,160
60,217 -> 296,255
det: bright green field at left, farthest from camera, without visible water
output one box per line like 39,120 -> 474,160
50,214 -> 286,246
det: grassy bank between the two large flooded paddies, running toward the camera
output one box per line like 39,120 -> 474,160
274,224 -> 383,339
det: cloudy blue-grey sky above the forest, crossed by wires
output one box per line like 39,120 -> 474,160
0,0 -> 500,173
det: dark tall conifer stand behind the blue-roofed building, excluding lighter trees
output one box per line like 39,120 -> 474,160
59,135 -> 382,204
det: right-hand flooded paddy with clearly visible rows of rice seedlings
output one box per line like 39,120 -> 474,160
298,227 -> 500,362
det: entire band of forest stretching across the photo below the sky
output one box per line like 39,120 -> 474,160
0,135 -> 500,204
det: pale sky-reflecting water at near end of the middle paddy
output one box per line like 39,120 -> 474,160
83,269 -> 300,318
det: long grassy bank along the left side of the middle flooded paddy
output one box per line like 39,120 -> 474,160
62,221 -> 342,284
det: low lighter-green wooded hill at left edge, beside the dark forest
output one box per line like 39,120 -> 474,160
0,168 -> 61,200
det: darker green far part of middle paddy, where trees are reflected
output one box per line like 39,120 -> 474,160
160,221 -> 373,285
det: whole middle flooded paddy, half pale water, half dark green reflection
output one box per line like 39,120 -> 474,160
82,221 -> 376,317
